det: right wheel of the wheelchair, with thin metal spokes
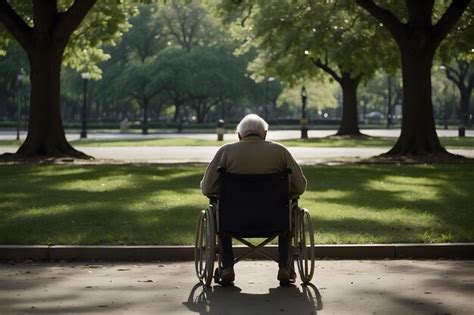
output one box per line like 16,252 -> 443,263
294,209 -> 315,284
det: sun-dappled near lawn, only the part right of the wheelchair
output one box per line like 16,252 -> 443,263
301,165 -> 474,243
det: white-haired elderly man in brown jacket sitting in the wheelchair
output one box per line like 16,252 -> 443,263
201,114 -> 306,285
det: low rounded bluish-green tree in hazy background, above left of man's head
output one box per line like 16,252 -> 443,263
155,44 -> 263,123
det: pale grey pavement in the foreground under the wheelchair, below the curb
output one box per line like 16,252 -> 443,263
0,260 -> 474,314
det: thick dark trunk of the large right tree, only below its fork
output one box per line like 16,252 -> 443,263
386,46 -> 446,155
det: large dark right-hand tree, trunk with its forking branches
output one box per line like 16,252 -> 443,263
356,0 -> 470,156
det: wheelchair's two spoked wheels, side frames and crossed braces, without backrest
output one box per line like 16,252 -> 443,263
194,184 -> 315,286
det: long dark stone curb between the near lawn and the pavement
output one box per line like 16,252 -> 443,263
0,243 -> 474,262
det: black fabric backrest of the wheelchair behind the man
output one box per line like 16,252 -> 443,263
219,170 -> 290,237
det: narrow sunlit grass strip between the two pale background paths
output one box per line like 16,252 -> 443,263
0,135 -> 474,148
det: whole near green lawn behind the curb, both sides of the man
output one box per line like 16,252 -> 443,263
0,165 -> 474,245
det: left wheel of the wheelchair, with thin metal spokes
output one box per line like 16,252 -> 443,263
194,207 -> 216,286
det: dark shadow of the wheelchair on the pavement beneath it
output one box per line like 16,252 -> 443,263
183,283 -> 323,314
